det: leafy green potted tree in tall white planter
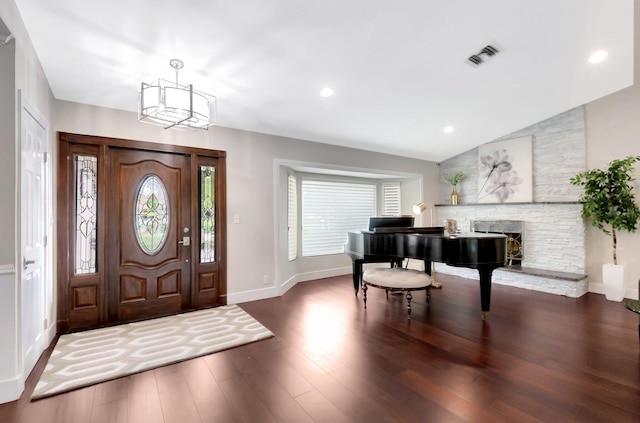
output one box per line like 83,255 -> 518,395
570,156 -> 640,301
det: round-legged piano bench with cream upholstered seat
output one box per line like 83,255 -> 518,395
362,267 -> 431,319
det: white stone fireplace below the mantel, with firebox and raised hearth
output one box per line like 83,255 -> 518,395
435,202 -> 588,297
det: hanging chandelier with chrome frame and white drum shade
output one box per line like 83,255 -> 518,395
138,59 -> 216,129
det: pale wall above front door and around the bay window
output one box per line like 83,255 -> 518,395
54,101 -> 437,302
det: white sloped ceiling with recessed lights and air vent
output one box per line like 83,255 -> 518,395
10,0 -> 633,161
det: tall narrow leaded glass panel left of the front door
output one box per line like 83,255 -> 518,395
75,156 -> 98,274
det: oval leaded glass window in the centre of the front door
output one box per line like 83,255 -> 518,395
133,175 -> 170,254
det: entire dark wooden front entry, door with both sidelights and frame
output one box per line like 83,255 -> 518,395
57,133 -> 227,332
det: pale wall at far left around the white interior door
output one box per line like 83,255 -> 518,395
0,0 -> 55,403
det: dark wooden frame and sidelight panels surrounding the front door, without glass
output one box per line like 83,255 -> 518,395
57,132 -> 227,333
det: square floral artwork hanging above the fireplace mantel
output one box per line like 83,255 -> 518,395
478,137 -> 533,203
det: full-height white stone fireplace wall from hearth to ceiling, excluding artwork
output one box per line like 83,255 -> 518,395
435,106 -> 588,297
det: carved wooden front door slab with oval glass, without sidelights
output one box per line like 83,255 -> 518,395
107,149 -> 191,321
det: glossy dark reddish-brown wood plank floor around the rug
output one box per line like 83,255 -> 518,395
0,275 -> 640,423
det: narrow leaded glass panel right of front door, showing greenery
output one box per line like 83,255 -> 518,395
200,166 -> 216,263
